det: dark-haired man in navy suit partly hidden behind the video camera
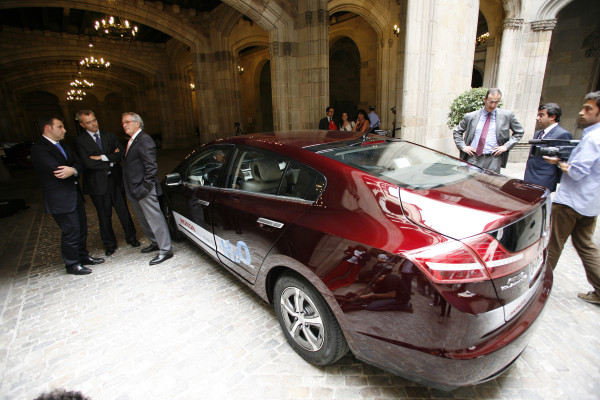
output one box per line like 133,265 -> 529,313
523,103 -> 573,192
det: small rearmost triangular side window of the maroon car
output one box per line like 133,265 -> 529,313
279,162 -> 325,201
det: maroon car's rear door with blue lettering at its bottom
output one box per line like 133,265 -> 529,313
212,147 -> 325,282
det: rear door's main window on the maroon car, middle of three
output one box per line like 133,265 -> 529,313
227,149 -> 287,194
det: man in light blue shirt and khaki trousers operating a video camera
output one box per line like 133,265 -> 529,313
544,91 -> 600,304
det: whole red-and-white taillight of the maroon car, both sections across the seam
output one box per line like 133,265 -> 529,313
406,233 -> 534,283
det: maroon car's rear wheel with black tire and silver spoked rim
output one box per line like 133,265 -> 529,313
273,273 -> 348,365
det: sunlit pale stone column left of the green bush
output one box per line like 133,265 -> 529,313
398,0 -> 479,153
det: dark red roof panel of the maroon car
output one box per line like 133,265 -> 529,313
216,129 -> 363,149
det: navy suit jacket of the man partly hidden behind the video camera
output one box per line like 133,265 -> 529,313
523,125 -> 573,192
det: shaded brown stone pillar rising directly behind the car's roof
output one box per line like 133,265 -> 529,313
269,0 -> 329,131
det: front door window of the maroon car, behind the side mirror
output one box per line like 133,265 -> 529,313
185,146 -> 232,186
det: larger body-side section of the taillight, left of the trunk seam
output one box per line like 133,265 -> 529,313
405,240 -> 490,283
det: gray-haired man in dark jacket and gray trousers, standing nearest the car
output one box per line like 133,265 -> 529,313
121,112 -> 173,265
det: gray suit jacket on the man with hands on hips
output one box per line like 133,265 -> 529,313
454,108 -> 525,168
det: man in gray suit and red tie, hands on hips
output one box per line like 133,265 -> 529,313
454,89 -> 524,173
